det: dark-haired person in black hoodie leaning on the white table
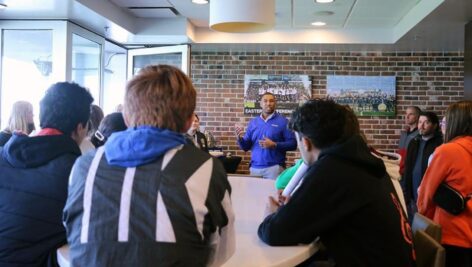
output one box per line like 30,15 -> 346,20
258,99 -> 414,267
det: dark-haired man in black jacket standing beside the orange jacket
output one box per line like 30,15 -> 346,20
401,111 -> 443,220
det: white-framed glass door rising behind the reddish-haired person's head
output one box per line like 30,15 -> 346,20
128,45 -> 190,80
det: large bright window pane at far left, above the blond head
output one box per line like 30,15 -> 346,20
1,30 -> 55,129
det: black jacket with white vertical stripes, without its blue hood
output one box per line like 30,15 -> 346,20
64,145 -> 235,266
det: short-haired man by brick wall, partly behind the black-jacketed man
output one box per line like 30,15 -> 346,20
397,106 -> 421,175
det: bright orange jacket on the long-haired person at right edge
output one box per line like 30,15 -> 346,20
417,136 -> 472,248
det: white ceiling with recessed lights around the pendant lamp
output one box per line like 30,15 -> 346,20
0,0 -> 472,50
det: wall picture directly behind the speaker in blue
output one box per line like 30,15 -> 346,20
244,75 -> 311,114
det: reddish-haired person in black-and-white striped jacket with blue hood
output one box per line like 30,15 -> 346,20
64,65 -> 235,266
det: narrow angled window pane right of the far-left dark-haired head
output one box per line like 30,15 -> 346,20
72,34 -> 101,104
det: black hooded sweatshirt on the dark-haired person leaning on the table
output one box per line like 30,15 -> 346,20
258,136 -> 414,267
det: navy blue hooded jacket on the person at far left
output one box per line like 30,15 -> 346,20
0,134 -> 80,266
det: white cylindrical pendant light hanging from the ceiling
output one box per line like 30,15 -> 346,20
210,0 -> 275,33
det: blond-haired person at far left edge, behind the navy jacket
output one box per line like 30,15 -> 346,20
0,101 -> 35,146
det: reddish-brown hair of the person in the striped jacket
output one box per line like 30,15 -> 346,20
123,65 -> 197,133
